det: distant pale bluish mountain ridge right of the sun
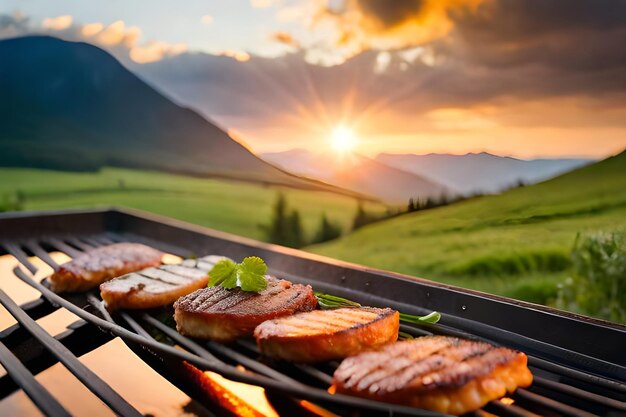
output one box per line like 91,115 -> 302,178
376,152 -> 593,194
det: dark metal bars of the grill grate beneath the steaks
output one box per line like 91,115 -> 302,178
0,208 -> 626,416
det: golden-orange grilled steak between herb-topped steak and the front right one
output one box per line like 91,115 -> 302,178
254,307 -> 400,362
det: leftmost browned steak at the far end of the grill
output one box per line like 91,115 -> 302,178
49,243 -> 163,293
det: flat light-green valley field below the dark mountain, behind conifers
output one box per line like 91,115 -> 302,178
0,168 -> 386,240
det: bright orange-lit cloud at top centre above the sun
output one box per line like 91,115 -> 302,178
278,0 -> 482,64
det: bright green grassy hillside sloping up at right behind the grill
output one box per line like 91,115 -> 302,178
307,153 -> 626,303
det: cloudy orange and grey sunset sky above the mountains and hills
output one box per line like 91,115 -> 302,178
0,0 -> 626,158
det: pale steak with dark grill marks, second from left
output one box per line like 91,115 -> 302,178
100,256 -> 224,310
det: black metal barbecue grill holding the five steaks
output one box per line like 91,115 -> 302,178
0,209 -> 626,417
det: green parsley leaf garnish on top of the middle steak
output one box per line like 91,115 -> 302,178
209,256 -> 267,292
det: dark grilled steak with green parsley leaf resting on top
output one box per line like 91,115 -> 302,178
174,277 -> 317,342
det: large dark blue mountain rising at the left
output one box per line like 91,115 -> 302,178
0,36 -> 348,189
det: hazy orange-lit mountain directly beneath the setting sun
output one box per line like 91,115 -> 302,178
261,149 -> 451,204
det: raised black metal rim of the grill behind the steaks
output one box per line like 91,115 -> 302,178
0,208 -> 626,415
